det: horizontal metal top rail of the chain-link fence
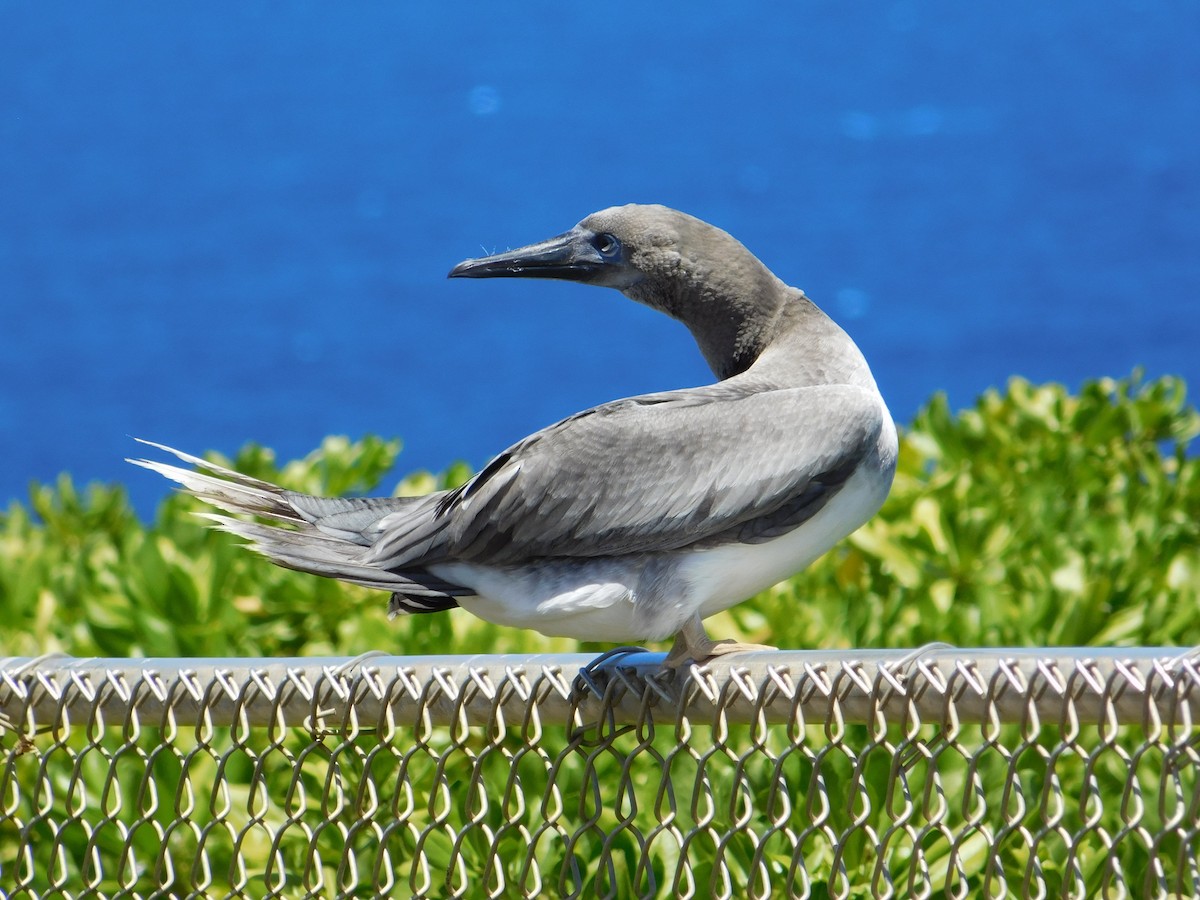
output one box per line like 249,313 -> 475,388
0,644 -> 1200,734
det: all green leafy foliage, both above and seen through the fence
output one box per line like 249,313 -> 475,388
0,373 -> 1200,896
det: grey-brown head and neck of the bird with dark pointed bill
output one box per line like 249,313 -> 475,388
450,204 -> 804,378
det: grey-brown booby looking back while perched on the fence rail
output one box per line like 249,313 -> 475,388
130,204 -> 898,668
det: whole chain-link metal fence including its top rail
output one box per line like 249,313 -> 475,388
0,647 -> 1200,899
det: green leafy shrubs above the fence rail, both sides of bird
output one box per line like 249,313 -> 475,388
0,374 -> 1200,656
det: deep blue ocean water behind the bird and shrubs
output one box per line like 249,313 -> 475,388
0,0 -> 1200,518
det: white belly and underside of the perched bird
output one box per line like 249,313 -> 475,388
430,412 -> 895,641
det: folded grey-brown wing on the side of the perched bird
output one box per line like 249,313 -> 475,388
365,382 -> 883,568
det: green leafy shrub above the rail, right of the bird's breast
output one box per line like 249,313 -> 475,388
734,376 -> 1200,647
